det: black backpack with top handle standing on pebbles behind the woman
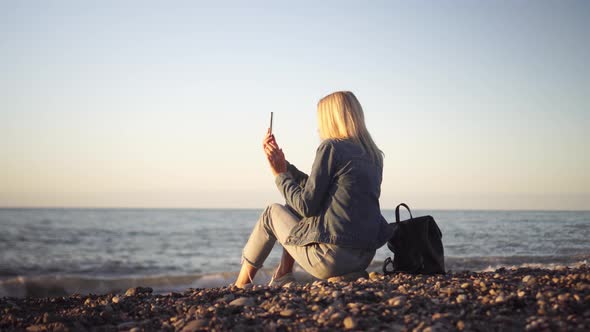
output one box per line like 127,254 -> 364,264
383,203 -> 445,274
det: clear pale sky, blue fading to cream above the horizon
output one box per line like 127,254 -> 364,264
0,0 -> 590,209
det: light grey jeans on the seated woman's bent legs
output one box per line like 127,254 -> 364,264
242,204 -> 375,279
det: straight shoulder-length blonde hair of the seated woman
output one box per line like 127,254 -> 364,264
318,91 -> 383,165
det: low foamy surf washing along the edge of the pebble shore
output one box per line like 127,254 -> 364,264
0,254 -> 590,298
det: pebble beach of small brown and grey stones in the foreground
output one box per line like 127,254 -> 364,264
0,264 -> 590,332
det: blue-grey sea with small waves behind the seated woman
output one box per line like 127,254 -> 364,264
0,208 -> 590,297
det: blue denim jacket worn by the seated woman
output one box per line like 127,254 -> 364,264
275,139 -> 392,249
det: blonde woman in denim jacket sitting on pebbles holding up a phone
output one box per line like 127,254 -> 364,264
235,91 -> 391,287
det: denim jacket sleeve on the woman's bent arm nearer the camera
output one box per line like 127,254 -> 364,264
275,141 -> 336,217
